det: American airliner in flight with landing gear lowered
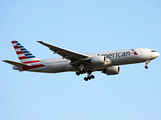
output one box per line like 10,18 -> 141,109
3,40 -> 160,81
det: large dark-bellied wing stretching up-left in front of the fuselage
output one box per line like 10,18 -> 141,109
37,41 -> 90,61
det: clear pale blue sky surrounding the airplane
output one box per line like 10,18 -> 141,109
0,0 -> 161,120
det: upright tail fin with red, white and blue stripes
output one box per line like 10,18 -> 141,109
11,41 -> 40,64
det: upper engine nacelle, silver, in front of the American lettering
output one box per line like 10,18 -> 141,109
90,56 -> 106,64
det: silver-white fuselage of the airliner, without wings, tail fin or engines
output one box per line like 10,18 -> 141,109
13,48 -> 159,73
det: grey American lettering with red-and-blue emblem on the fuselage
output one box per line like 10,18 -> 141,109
101,49 -> 138,58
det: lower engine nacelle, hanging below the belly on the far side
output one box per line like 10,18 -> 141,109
103,66 -> 120,75
